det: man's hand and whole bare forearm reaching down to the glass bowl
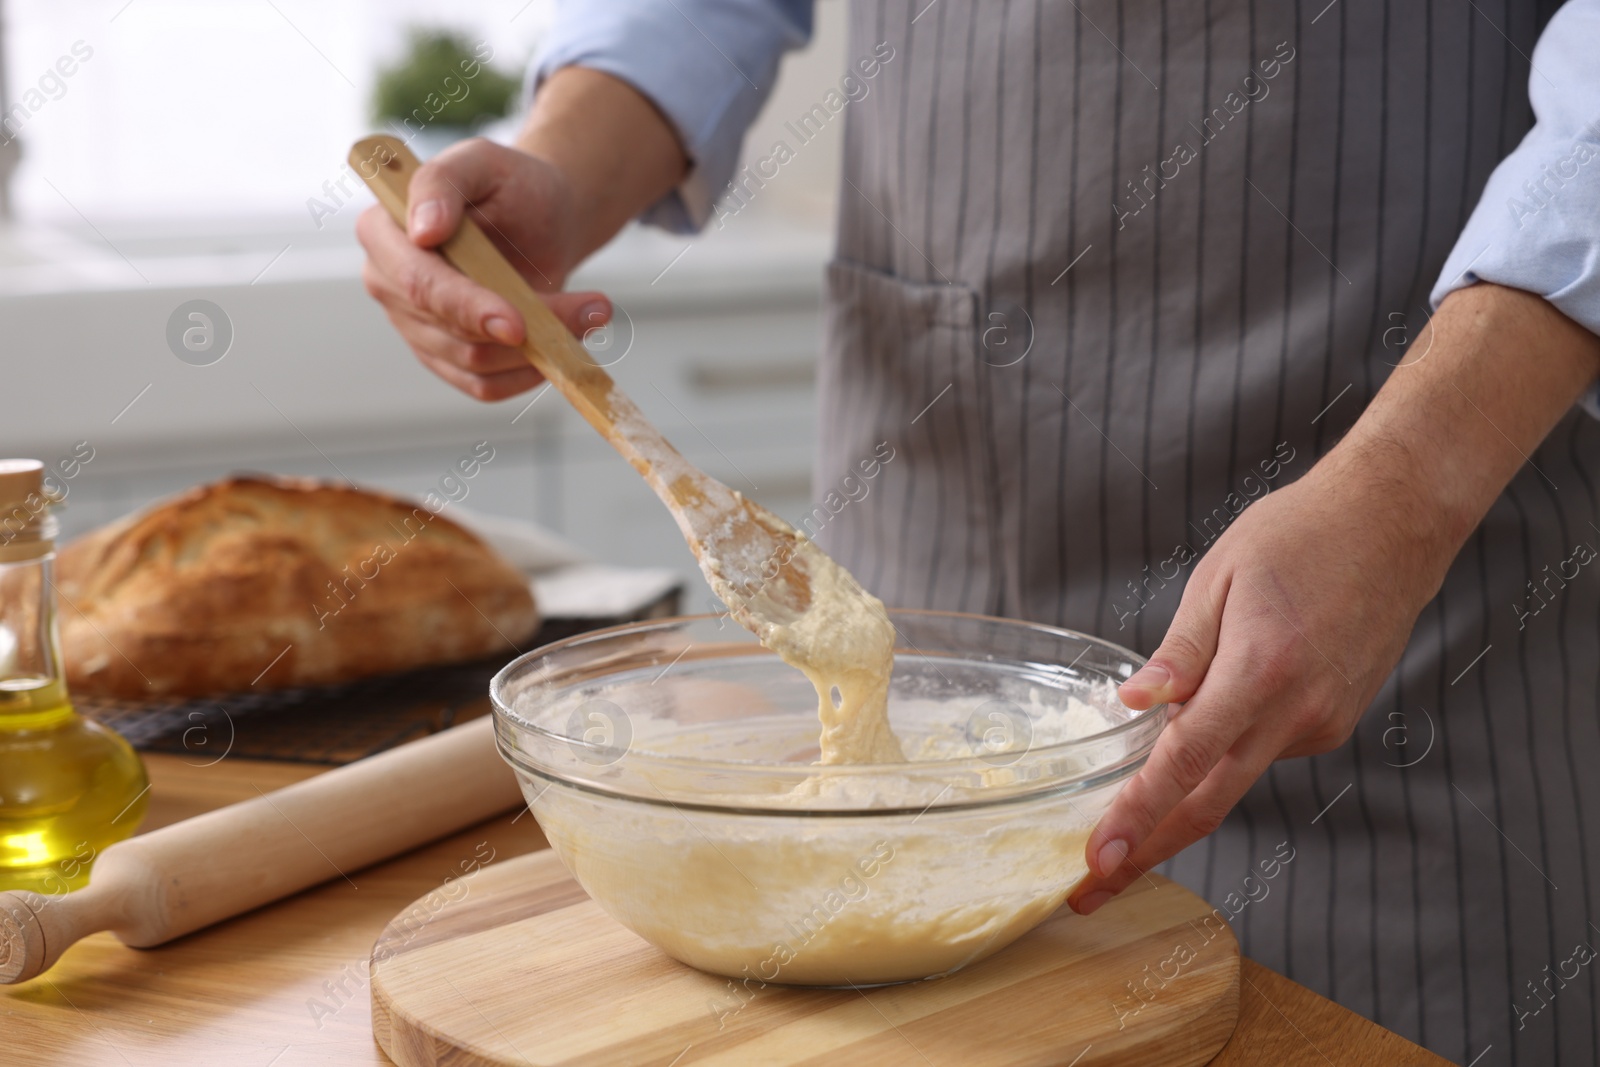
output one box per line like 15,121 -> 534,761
1069,285 -> 1600,915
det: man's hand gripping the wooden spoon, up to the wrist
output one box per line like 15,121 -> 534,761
355,139 -> 611,400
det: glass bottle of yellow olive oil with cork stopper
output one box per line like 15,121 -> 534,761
0,459 -> 149,894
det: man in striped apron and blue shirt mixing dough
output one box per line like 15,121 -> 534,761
360,0 -> 1600,1064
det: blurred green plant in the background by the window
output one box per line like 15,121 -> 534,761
373,27 -> 520,126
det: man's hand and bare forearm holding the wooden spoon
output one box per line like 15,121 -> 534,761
355,67 -> 688,400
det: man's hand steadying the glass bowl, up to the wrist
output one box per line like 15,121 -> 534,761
1072,456 -> 1454,915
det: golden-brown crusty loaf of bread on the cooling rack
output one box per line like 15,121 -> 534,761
56,477 -> 538,699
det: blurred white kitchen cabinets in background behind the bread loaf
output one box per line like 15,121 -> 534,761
0,227 -> 827,588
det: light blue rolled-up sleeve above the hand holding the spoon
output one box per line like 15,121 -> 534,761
530,0 -> 813,234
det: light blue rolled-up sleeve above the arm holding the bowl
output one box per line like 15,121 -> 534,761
1430,0 -> 1600,418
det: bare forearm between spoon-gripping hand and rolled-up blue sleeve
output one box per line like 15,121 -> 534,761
517,67 -> 690,269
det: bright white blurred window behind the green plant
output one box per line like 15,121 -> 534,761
0,0 -> 552,239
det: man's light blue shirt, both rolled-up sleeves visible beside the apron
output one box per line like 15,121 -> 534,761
534,0 -> 1600,399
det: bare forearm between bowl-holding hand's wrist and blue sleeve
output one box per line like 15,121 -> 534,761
1323,285 -> 1600,587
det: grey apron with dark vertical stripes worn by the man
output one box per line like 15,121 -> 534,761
818,0 -> 1600,1065
